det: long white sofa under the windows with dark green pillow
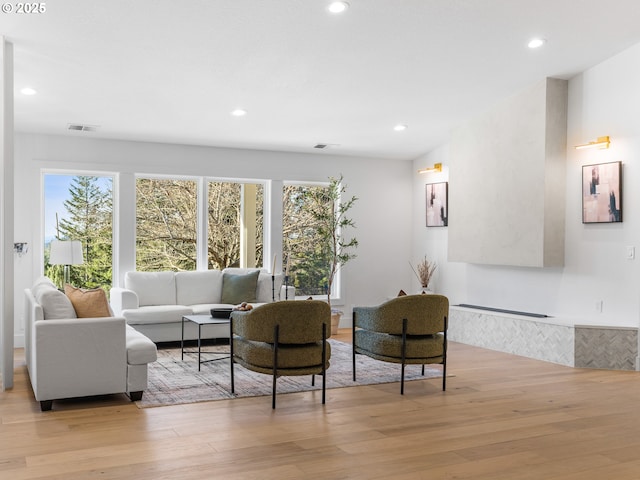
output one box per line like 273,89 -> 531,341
110,268 -> 295,342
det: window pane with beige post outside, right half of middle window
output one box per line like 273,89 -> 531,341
207,181 -> 264,269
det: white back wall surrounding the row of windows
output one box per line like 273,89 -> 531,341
15,133 -> 412,345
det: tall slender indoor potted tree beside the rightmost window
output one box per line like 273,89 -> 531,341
308,175 -> 358,334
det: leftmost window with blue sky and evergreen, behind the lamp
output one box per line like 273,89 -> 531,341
44,174 -> 113,291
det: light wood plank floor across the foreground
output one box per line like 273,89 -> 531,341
0,330 -> 640,480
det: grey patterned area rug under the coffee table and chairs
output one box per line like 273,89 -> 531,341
136,339 -> 442,408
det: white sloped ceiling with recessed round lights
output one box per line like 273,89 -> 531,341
5,0 -> 640,160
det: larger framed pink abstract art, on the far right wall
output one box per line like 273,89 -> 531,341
582,162 -> 622,223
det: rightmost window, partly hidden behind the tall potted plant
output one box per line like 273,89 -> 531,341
282,185 -> 339,296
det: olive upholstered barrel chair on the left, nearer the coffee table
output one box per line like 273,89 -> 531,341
229,300 -> 331,408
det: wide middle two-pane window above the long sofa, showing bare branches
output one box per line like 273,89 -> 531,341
136,178 -> 264,271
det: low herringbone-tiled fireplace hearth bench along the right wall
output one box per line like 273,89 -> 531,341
448,306 -> 638,370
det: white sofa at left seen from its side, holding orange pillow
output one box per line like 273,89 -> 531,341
25,277 -> 157,411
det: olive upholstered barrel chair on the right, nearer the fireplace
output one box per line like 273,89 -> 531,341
352,294 -> 449,394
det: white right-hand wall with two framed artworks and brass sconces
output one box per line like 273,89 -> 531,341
413,44 -> 640,326
